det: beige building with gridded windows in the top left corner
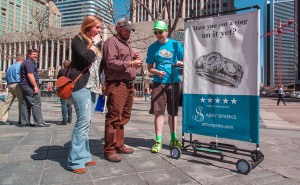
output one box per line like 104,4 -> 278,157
0,0 -> 61,34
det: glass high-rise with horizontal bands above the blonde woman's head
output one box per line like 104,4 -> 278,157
55,0 -> 113,27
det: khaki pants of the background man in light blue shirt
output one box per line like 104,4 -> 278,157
0,83 -> 23,123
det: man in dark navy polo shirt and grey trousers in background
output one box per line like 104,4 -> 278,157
20,49 -> 50,127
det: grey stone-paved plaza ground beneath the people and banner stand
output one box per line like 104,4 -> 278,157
0,98 -> 300,185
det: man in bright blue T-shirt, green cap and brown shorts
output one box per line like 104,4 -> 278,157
146,21 -> 183,153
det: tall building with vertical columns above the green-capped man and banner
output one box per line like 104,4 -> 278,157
131,0 -> 234,22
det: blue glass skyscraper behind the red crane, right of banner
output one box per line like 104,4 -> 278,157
264,0 -> 297,86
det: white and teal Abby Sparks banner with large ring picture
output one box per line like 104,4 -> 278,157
182,10 -> 260,144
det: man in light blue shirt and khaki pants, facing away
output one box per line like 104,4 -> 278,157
1,54 -> 24,125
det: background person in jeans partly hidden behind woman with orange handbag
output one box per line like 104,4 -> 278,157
53,60 -> 73,125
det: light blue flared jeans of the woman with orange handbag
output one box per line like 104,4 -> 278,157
67,88 -> 96,170
